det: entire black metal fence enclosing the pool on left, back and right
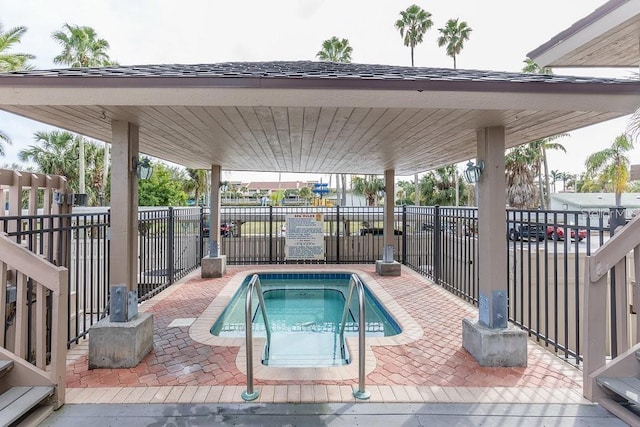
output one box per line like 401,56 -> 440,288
0,206 -> 620,363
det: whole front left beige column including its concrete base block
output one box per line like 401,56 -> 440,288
89,121 -> 153,369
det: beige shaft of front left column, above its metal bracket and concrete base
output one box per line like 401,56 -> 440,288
109,121 -> 138,290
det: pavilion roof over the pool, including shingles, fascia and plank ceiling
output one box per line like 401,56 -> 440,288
0,61 -> 640,175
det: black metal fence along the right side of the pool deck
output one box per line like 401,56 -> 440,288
403,206 -> 610,363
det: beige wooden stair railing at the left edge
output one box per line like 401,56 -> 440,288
0,233 -> 68,407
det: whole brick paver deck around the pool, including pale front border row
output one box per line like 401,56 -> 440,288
67,265 -> 588,403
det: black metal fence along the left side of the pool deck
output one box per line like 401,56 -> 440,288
0,208 -> 202,354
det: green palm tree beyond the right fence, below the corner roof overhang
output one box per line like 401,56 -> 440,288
585,133 -> 633,206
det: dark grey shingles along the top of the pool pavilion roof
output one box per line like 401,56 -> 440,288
0,61 -> 632,88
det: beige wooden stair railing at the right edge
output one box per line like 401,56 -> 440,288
583,216 -> 640,401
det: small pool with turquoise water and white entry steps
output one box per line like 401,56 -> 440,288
210,272 -> 401,367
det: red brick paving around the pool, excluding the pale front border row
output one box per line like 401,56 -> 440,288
67,265 -> 578,388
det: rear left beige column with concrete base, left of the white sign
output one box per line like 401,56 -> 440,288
200,165 -> 227,278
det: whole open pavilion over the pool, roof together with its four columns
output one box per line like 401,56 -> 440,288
0,61 -> 640,374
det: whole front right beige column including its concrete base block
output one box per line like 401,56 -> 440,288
462,127 -> 527,366
